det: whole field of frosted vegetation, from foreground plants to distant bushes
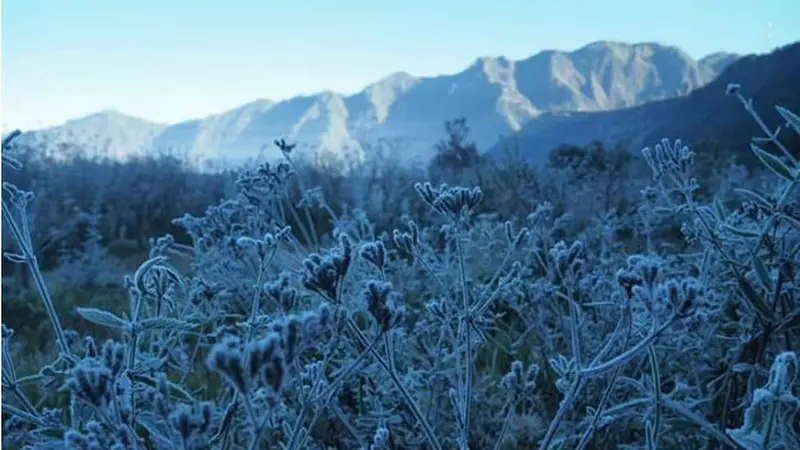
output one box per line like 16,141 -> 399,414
2,85 -> 800,450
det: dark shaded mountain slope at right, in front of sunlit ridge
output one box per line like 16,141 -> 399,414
489,43 -> 800,161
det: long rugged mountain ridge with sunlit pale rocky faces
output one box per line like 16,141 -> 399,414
17,41 -> 736,165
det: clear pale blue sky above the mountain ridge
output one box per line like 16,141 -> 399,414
2,0 -> 800,130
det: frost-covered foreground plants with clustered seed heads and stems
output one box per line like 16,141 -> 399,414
2,85 -> 800,450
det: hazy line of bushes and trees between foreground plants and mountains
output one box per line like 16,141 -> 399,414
3,118 -> 788,284
